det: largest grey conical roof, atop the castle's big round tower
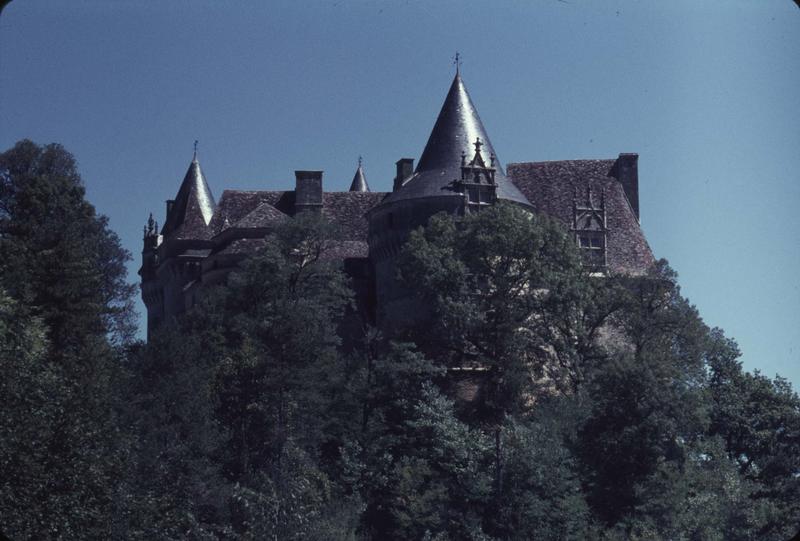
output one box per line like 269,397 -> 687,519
384,73 -> 530,205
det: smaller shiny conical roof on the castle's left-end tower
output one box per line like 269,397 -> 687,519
161,155 -> 216,238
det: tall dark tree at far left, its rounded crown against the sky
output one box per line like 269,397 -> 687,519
0,140 -> 136,355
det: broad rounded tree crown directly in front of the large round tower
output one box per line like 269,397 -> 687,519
399,203 -> 608,425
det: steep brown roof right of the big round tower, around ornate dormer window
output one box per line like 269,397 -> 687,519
508,160 -> 654,274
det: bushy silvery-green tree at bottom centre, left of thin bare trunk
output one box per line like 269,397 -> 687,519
357,344 -> 492,539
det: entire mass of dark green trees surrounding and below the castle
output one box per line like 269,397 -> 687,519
0,141 -> 800,541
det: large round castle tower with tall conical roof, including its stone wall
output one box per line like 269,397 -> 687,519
368,72 -> 531,327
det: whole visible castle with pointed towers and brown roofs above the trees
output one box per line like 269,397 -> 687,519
139,72 -> 653,332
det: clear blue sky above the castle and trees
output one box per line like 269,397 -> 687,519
0,0 -> 800,389
